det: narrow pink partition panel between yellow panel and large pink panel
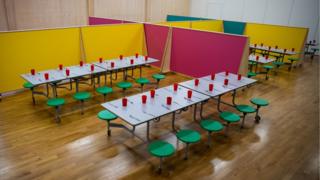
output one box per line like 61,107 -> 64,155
144,24 -> 169,67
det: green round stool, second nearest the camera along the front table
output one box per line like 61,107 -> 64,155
176,129 -> 200,160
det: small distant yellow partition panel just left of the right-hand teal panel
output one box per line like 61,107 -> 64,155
191,20 -> 223,32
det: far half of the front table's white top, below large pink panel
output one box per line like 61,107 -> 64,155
179,72 -> 257,97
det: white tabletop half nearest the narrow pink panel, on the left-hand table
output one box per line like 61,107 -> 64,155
94,55 -> 159,70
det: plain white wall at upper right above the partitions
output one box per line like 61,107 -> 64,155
190,0 -> 319,42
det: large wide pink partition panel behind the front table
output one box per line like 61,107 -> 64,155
170,28 -> 247,77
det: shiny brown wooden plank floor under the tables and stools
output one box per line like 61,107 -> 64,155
0,57 -> 319,180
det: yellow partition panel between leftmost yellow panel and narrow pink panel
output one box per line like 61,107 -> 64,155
81,24 -> 145,62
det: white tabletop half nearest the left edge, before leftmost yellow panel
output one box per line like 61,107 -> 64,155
21,64 -> 105,85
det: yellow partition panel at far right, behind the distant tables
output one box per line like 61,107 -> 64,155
244,23 -> 308,59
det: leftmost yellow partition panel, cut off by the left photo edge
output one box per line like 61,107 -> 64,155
0,28 -> 81,92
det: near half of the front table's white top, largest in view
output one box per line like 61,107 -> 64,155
102,85 -> 210,125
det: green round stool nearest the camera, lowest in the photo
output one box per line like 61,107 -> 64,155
148,140 -> 175,173
